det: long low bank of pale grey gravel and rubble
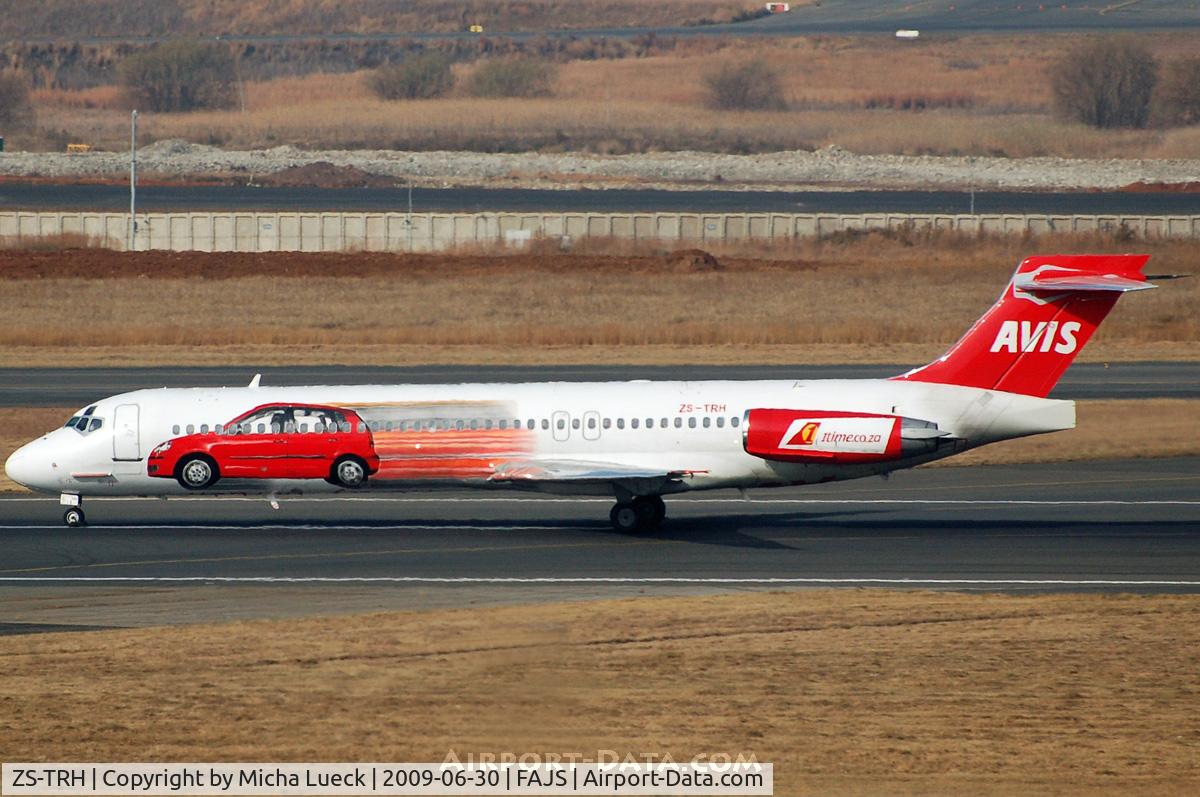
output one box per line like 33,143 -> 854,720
0,140 -> 1200,190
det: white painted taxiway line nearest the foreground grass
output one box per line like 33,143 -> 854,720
0,576 -> 1200,587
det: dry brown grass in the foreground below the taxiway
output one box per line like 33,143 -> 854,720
0,591 -> 1200,795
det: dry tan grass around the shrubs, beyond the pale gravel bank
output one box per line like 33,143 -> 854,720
23,34 -> 1200,157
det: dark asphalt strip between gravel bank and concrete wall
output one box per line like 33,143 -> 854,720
0,182 -> 1200,216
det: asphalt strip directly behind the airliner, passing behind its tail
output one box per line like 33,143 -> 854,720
0,362 -> 1200,407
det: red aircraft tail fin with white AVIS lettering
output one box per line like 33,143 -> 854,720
895,254 -> 1156,396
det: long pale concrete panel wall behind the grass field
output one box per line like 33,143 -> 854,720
0,212 -> 1200,252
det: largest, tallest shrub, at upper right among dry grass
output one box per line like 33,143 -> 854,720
1050,38 -> 1158,127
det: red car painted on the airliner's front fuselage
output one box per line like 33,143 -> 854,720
146,403 -> 379,490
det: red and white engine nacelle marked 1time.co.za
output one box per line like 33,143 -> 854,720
742,409 -> 949,465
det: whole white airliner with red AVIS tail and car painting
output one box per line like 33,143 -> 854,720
5,254 -> 1154,532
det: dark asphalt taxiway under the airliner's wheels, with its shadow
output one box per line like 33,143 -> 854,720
0,457 -> 1200,633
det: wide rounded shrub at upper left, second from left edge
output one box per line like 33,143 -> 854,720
118,41 -> 238,110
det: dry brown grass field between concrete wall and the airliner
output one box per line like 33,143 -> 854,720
0,234 -> 1200,361
